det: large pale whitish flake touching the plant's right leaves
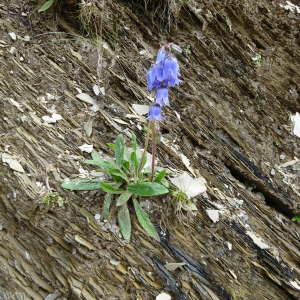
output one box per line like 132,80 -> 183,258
170,172 -> 206,198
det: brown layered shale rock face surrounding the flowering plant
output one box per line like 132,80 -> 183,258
0,0 -> 300,300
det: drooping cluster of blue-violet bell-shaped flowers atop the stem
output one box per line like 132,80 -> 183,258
146,44 -> 182,121
